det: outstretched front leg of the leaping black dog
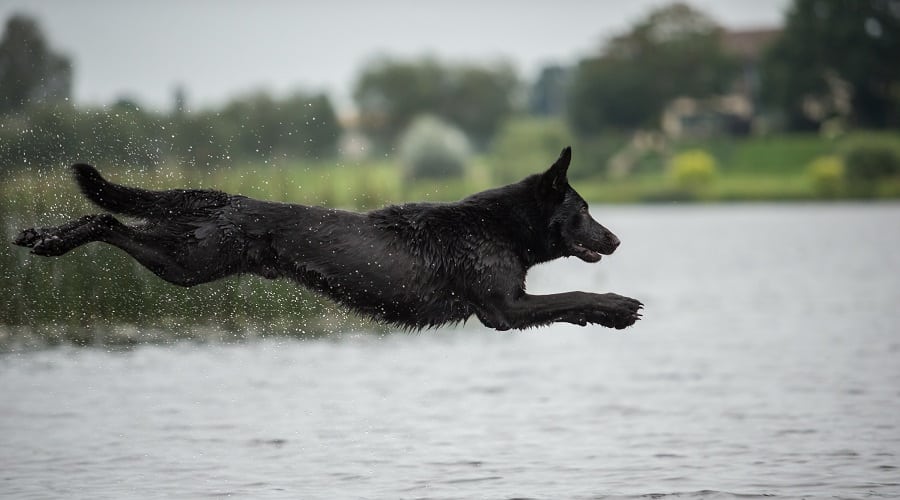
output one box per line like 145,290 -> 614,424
478,292 -> 643,330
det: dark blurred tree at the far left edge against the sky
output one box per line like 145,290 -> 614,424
0,15 -> 72,114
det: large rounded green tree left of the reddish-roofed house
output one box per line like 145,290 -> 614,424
568,4 -> 737,135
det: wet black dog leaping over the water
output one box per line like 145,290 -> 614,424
14,148 -> 642,330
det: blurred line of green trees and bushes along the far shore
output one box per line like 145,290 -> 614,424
0,0 -> 900,180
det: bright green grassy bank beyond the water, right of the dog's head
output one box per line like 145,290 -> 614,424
573,132 -> 900,203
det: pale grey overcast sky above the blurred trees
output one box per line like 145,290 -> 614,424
0,0 -> 789,110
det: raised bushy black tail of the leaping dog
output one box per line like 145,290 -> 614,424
72,163 -> 228,219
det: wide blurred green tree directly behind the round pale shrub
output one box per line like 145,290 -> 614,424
354,59 -> 518,148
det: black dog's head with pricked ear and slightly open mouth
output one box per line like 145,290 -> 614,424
539,147 -> 619,262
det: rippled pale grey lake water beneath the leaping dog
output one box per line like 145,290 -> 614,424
0,204 -> 900,499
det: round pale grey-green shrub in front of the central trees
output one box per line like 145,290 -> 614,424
400,115 -> 471,179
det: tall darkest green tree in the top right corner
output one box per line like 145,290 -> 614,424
763,0 -> 900,129
